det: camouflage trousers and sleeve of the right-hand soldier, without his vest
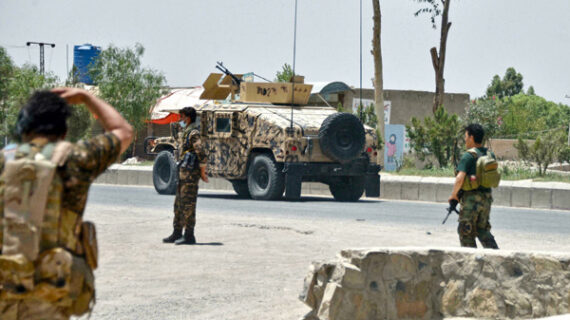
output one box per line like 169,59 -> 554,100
457,148 -> 498,249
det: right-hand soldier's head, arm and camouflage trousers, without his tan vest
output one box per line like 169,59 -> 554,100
449,124 -> 499,249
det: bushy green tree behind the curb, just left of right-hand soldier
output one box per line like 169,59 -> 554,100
406,107 -> 463,168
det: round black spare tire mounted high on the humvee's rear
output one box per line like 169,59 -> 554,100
319,112 -> 365,163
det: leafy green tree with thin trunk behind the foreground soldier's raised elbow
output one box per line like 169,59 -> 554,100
90,43 -> 166,156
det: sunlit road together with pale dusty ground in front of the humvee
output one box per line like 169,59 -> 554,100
85,185 -> 570,320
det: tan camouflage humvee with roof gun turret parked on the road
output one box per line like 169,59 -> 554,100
144,69 -> 380,201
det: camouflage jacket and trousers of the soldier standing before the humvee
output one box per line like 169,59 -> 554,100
173,127 -> 207,231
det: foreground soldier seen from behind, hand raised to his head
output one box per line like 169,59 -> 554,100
0,88 -> 133,320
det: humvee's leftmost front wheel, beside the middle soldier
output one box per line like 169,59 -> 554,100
152,151 -> 178,194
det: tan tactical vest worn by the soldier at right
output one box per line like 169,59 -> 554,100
461,148 -> 501,191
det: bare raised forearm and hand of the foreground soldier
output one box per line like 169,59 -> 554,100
52,88 -> 133,153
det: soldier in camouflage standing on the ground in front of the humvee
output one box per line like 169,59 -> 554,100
162,107 -> 208,245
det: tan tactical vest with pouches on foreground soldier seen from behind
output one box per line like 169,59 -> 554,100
0,139 -> 97,315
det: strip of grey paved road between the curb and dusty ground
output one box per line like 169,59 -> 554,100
89,185 -> 570,236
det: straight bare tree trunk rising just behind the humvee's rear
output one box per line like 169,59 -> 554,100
372,0 -> 384,163
